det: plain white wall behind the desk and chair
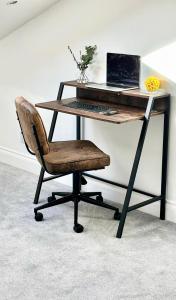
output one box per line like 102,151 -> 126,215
0,0 -> 176,222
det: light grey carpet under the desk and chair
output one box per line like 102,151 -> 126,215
0,164 -> 176,300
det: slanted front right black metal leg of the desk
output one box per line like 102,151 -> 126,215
116,97 -> 154,238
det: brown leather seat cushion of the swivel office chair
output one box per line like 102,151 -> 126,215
44,140 -> 110,174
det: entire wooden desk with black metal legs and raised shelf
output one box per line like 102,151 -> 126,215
35,81 -> 170,238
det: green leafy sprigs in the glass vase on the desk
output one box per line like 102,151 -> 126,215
68,45 -> 97,71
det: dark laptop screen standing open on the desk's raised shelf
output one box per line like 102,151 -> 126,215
106,53 -> 140,86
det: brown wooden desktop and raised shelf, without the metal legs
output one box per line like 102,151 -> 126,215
36,81 -> 168,124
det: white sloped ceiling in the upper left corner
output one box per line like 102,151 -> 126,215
0,0 -> 58,39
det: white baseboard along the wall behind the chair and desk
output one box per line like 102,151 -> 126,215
0,147 -> 176,223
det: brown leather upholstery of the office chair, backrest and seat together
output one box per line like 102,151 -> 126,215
16,97 -> 110,174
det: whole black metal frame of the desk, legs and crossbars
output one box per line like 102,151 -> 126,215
34,82 -> 170,238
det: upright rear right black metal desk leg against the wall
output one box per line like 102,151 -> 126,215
160,102 -> 169,220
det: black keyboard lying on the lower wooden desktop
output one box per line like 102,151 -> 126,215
64,101 -> 111,113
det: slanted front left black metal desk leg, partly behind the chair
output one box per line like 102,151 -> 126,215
34,82 -> 64,204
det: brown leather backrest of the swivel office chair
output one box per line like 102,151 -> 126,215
15,97 -> 49,163
